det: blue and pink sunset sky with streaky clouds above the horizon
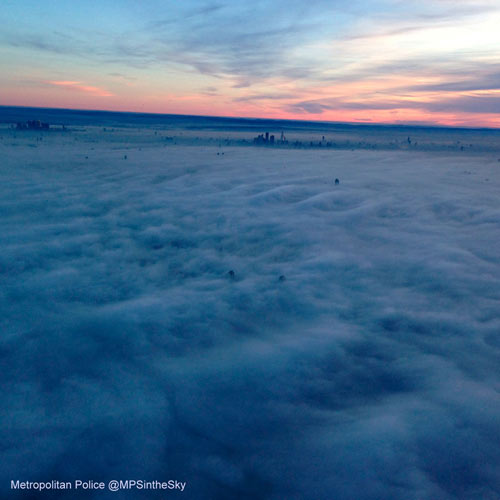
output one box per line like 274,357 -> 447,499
0,0 -> 500,127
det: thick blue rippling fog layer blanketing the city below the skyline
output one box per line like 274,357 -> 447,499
0,130 -> 500,500
